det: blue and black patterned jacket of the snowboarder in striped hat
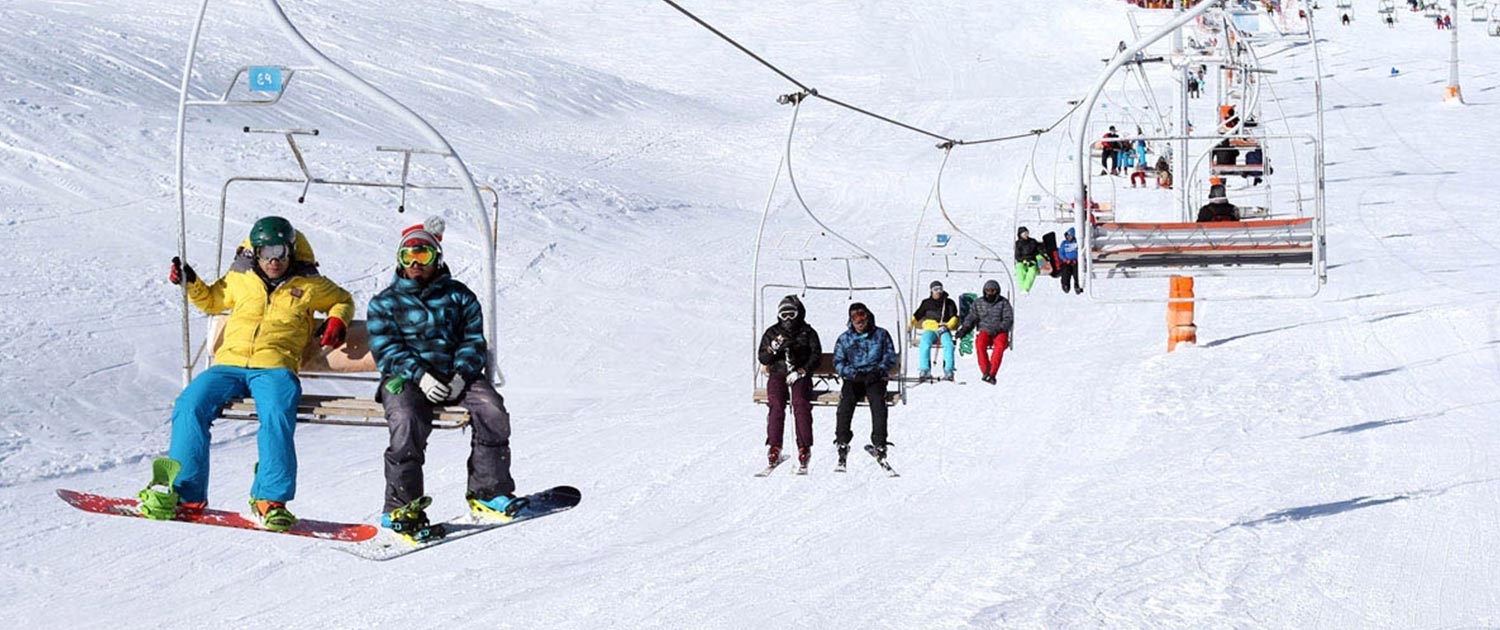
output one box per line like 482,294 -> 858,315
369,267 -> 489,383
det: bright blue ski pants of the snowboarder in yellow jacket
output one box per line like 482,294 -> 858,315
168,366 -> 302,503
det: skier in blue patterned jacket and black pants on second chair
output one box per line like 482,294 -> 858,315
834,302 -> 899,464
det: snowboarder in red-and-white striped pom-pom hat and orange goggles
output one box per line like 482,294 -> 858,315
369,218 -> 519,531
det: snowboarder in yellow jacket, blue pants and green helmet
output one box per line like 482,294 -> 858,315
159,216 -> 354,531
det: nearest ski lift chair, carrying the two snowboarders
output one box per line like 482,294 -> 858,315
176,0 -> 504,429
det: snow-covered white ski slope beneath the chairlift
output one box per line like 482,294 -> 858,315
0,0 -> 1500,629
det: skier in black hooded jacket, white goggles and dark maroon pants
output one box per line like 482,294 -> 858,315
758,296 -> 824,465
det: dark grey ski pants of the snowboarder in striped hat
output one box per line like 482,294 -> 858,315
381,373 -> 516,512
